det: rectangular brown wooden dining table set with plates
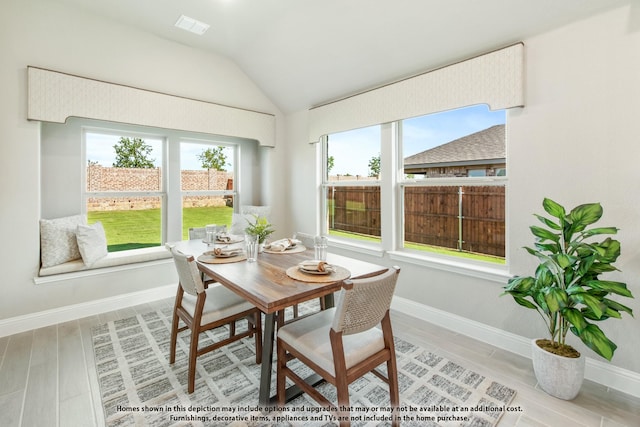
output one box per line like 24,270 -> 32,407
170,240 -> 388,406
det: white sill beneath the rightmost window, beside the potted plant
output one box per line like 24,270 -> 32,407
388,251 -> 511,284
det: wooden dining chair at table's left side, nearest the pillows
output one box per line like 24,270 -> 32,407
169,248 -> 262,393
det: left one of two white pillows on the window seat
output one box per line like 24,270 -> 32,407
40,215 -> 87,268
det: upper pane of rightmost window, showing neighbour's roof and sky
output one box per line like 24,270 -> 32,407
402,105 -> 506,179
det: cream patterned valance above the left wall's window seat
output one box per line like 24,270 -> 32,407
27,67 -> 275,147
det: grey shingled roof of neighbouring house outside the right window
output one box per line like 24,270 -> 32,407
404,125 -> 506,170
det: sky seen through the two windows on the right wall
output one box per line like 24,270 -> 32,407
329,104 -> 506,176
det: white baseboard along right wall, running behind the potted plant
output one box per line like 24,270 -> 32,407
391,296 -> 640,397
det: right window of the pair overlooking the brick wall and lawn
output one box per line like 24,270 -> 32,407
180,140 -> 237,239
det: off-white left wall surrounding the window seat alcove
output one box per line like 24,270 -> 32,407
0,0 -> 282,321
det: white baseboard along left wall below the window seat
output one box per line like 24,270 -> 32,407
0,284 -> 177,338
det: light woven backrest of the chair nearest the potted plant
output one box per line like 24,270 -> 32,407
332,267 -> 400,335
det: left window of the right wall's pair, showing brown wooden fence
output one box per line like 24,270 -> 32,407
322,126 -> 381,243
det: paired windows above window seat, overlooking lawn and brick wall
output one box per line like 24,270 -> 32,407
83,126 -> 240,252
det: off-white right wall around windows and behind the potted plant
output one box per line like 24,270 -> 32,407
286,3 -> 640,380
